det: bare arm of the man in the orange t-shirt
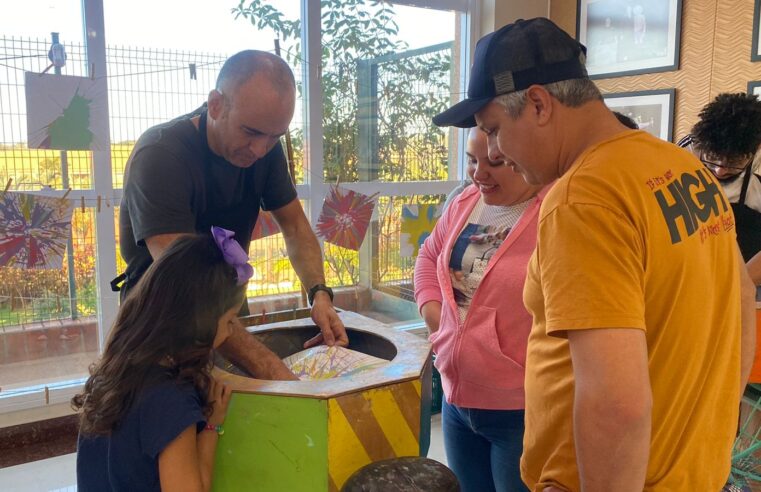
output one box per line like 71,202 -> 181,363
562,328 -> 653,492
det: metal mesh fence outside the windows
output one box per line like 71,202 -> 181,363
0,32 -> 453,327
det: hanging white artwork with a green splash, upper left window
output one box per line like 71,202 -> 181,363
24,72 -> 109,150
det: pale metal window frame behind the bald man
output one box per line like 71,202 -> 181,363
0,0 -> 479,416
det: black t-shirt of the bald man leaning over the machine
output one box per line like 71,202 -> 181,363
119,108 -> 296,270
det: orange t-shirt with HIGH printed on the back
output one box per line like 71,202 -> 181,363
521,131 -> 741,491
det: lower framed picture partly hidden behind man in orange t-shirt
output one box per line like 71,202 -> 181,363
603,89 -> 676,142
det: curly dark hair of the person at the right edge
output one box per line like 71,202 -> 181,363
692,93 -> 761,159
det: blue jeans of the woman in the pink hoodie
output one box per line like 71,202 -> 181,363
441,398 -> 528,492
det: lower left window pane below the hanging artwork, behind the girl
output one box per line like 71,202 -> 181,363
0,207 -> 98,392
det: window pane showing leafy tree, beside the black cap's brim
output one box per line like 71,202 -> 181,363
322,0 -> 460,182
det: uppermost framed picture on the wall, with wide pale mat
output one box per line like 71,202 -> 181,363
576,0 -> 684,79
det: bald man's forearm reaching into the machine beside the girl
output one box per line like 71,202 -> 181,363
219,326 -> 298,380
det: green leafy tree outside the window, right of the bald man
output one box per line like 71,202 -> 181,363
231,0 -> 452,182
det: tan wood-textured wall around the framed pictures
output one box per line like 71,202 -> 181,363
550,0 -> 761,140
